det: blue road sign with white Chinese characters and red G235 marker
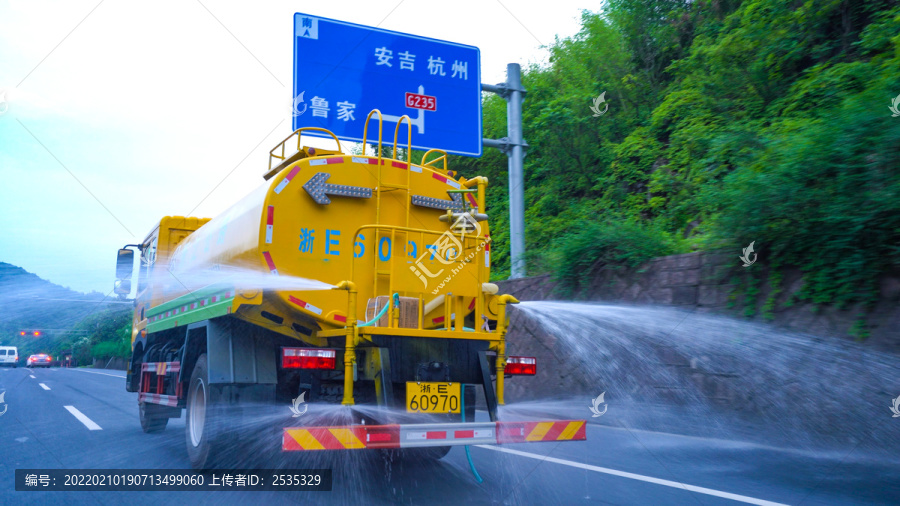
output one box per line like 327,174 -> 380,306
293,13 -> 482,156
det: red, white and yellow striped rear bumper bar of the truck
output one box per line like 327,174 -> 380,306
281,420 -> 587,451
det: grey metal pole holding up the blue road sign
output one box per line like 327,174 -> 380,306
481,63 -> 528,279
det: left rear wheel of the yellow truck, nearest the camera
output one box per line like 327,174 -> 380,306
184,353 -> 225,469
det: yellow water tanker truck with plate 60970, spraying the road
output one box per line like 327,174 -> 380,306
116,110 -> 585,469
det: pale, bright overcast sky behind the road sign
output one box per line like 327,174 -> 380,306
0,0 -> 601,294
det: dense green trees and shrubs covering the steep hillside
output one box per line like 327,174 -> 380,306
451,0 -> 900,305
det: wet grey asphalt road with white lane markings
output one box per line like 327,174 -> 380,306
0,368 -> 900,506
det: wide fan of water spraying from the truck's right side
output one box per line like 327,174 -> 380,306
505,302 -> 900,448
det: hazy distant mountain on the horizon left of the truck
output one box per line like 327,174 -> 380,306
0,262 -> 130,353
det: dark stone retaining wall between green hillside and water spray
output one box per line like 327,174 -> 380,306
497,252 -> 900,354
